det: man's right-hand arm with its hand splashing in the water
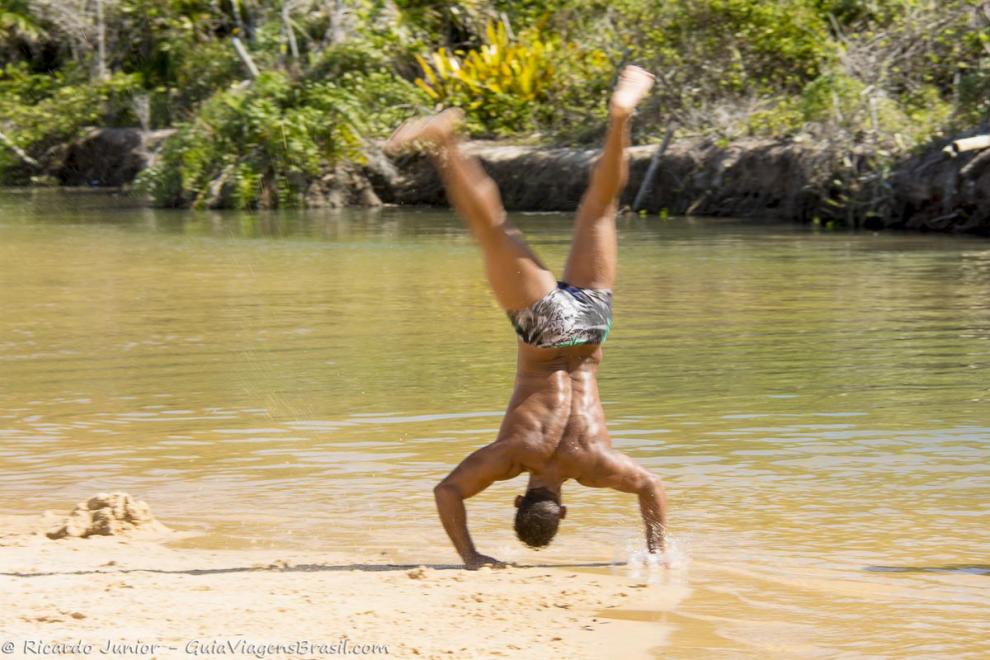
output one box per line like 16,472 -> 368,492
578,449 -> 667,552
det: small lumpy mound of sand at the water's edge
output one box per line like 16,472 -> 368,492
47,493 -> 168,539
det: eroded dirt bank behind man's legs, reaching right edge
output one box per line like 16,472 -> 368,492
370,139 -> 990,235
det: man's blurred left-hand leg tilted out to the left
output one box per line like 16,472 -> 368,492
386,110 -> 557,311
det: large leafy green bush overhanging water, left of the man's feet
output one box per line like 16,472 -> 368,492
137,72 -> 421,208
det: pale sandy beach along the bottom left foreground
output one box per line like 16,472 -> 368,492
0,516 -> 672,658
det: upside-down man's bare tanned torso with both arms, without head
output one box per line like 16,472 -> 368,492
433,336 -> 666,568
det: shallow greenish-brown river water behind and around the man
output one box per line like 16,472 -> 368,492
0,192 -> 990,657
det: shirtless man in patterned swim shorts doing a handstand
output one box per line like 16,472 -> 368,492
386,66 -> 667,569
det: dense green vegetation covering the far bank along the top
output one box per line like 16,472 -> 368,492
0,0 -> 990,207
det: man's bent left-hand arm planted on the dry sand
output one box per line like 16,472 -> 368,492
433,443 -> 522,570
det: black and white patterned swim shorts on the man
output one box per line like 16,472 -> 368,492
508,282 -> 612,348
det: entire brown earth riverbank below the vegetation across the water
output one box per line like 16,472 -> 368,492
35,129 -> 990,235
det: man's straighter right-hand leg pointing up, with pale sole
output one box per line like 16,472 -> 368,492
564,66 -> 653,289
